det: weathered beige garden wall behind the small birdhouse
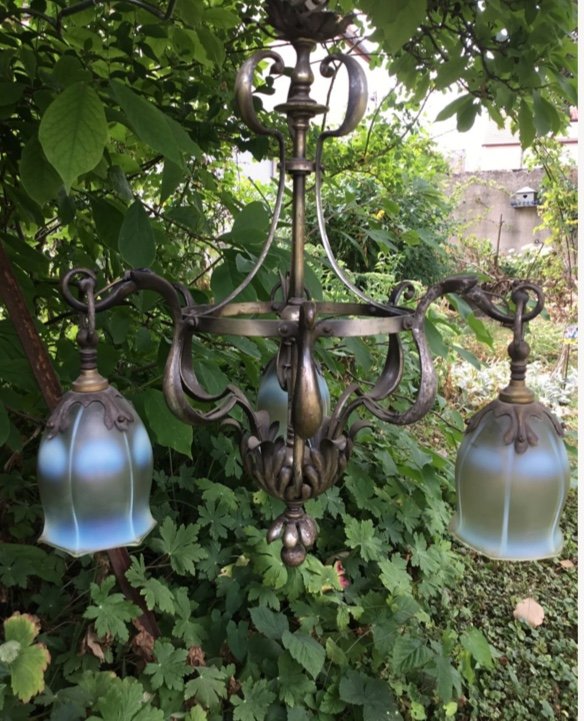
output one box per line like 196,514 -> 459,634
449,168 -> 549,253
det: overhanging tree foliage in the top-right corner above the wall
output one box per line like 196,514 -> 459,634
342,0 -> 577,147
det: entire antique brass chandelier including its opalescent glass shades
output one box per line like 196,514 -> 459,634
38,0 -> 569,566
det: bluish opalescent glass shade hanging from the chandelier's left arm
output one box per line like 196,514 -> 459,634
37,397 -> 156,556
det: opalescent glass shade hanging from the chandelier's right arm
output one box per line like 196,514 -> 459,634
451,404 -> 570,561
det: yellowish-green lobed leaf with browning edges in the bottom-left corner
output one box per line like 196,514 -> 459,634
0,613 -> 51,703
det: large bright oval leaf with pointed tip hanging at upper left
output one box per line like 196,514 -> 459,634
39,82 -> 108,193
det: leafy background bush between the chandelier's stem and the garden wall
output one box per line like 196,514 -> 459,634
308,114 -> 450,284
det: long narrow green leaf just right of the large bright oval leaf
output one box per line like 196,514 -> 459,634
110,80 -> 200,168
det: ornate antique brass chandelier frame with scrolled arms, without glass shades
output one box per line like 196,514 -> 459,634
38,0 -> 561,565
